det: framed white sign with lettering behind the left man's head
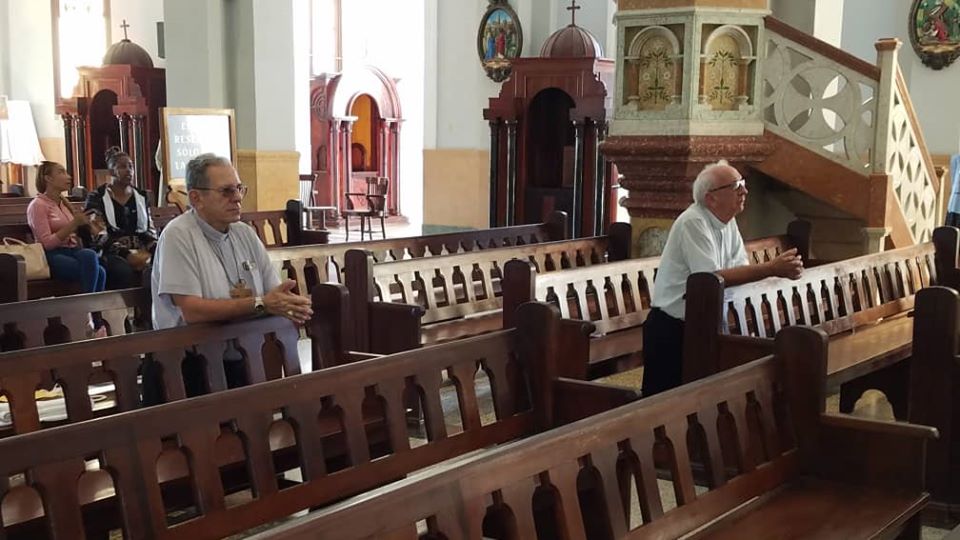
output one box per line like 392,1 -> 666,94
159,107 -> 237,210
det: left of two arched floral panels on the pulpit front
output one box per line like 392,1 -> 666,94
623,26 -> 683,111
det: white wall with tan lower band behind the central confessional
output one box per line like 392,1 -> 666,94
423,0 -> 616,227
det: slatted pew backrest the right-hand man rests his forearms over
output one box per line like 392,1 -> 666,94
724,242 -> 937,338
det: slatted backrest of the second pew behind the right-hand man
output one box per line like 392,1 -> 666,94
372,236 -> 609,323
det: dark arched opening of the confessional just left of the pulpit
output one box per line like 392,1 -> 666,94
521,88 -> 576,223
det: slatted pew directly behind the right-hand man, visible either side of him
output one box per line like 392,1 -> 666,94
503,224 -> 810,379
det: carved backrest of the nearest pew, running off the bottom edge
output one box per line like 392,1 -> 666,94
251,328 -> 826,540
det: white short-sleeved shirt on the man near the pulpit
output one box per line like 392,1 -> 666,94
652,203 -> 748,319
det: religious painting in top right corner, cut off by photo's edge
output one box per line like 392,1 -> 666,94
907,0 -> 960,69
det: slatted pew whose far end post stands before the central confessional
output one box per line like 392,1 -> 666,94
270,212 -> 568,294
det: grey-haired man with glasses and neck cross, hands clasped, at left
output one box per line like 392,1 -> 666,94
144,154 -> 313,402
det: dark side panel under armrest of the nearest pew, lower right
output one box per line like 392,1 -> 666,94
817,413 -> 939,492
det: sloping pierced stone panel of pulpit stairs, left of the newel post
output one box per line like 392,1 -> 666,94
760,32 -> 878,174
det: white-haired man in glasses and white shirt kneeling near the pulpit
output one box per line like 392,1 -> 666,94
643,160 -> 803,396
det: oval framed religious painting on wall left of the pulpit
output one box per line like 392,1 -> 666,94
477,0 -> 523,82
